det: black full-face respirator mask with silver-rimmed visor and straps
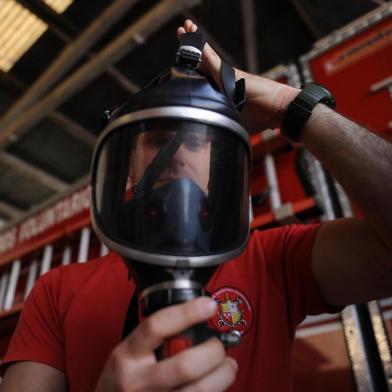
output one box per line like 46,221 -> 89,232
92,33 -> 250,356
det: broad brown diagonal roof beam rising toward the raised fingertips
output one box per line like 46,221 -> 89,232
0,0 -> 200,146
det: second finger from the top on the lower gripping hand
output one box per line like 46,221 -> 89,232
152,338 -> 225,390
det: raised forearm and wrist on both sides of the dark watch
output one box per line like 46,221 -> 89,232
231,65 -> 392,253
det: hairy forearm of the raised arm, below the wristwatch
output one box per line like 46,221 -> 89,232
301,104 -> 392,252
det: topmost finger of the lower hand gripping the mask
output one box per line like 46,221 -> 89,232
123,297 -> 216,356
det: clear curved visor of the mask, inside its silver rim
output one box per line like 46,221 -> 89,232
92,119 -> 249,264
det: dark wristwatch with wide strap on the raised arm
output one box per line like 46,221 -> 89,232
281,83 -> 335,142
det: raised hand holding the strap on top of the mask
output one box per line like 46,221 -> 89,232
177,19 -> 300,132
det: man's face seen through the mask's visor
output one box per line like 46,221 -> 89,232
129,131 -> 211,195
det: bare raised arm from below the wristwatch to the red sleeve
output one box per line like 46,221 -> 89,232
301,105 -> 392,305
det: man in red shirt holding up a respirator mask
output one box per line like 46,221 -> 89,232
1,21 -> 392,391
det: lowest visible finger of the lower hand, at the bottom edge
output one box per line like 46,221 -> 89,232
178,357 -> 238,392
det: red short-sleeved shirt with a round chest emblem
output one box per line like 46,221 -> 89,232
3,225 -> 336,392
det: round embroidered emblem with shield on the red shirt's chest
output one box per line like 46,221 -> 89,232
211,287 -> 253,335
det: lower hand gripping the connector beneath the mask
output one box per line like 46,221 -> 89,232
96,297 -> 237,392
